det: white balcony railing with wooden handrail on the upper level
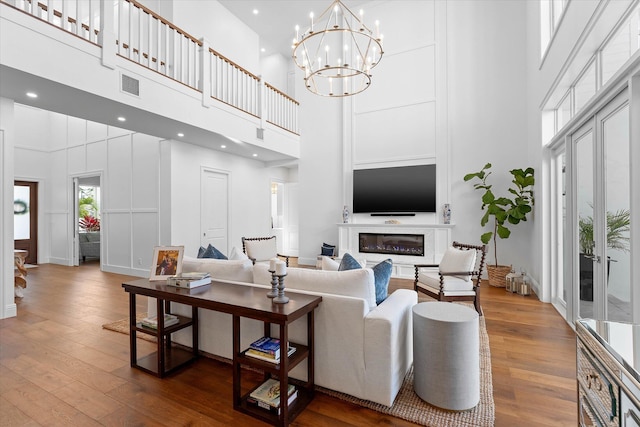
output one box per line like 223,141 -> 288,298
0,0 -> 299,135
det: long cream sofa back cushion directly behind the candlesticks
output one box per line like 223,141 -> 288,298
253,264 -> 376,309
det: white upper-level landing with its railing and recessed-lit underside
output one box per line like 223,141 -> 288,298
0,0 -> 300,165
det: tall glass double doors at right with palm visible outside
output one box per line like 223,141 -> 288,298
572,92 -> 632,321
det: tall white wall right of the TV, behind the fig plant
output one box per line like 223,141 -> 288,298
447,1 -> 528,278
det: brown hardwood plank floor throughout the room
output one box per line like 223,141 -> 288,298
0,262 -> 577,427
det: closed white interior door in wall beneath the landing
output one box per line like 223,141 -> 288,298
200,169 -> 229,256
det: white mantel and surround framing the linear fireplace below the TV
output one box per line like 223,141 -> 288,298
338,223 -> 455,279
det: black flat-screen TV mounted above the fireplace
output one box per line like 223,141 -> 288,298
353,165 -> 436,215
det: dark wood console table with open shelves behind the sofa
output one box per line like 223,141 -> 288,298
122,279 -> 322,426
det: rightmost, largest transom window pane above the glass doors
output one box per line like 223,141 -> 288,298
602,7 -> 640,84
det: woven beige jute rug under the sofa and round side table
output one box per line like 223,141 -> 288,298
102,313 -> 495,427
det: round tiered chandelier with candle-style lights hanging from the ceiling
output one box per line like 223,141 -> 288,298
292,0 -> 384,97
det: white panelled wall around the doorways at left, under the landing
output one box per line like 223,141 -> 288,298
15,104 -> 168,275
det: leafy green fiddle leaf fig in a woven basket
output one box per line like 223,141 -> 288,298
464,163 -> 535,287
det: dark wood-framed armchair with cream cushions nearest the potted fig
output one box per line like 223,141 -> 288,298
413,242 -> 487,316
